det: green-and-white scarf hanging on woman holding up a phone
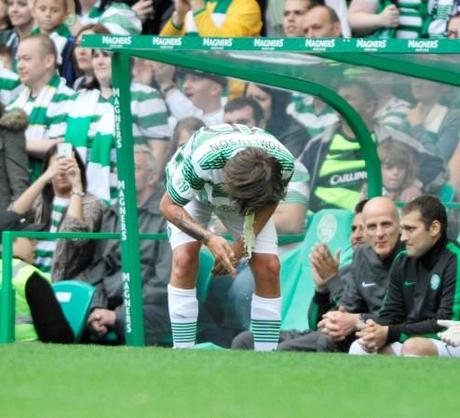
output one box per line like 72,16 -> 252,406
35,196 -> 70,273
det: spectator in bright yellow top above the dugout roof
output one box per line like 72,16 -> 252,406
160,0 -> 262,37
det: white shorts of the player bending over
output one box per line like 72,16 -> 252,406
168,199 -> 278,255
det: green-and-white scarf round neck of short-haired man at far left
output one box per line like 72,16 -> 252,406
7,74 -> 60,181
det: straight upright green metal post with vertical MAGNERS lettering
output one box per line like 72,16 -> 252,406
112,53 -> 144,346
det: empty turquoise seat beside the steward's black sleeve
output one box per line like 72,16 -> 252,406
53,280 -> 95,342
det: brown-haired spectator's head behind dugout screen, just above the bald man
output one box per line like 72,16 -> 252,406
377,140 -> 422,200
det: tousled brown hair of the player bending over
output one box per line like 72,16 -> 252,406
224,147 -> 287,215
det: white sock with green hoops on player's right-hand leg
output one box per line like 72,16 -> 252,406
251,294 -> 281,351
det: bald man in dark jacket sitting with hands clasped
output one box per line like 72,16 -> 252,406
317,197 -> 402,352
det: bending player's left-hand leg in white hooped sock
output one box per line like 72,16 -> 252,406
168,201 -> 210,348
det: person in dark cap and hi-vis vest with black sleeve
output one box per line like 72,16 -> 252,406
0,211 -> 74,343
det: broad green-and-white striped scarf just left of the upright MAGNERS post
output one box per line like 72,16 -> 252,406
65,90 -> 118,206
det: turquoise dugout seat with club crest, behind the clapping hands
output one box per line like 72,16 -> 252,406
280,209 -> 353,331
